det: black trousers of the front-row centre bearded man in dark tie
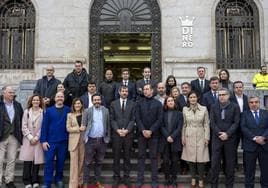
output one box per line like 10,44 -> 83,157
112,134 -> 133,179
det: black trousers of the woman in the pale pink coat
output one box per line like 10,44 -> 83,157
22,161 -> 40,185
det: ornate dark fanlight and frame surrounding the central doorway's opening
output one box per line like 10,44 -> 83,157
89,0 -> 162,80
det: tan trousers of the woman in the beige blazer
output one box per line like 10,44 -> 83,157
69,136 -> 85,188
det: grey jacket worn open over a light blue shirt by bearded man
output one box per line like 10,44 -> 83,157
82,106 -> 111,143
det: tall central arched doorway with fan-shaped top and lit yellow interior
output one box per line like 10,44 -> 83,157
89,0 -> 162,81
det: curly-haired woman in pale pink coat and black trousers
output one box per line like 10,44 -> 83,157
19,95 -> 44,188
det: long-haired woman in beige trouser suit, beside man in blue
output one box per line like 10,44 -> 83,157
66,98 -> 86,188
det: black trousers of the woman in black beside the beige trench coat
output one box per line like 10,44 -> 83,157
163,143 -> 179,180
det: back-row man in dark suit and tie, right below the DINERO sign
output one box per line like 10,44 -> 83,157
191,67 -> 210,99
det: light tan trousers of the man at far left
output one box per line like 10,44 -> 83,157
0,135 -> 19,185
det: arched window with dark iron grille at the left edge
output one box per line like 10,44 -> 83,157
0,0 -> 35,69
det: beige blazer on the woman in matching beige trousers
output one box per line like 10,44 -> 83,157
66,113 -> 81,151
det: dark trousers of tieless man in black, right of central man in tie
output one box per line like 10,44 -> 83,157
137,136 -> 158,184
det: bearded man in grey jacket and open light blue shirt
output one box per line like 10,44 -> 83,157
82,94 -> 110,188
